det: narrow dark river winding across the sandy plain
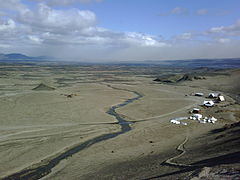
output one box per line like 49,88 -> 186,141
3,84 -> 143,180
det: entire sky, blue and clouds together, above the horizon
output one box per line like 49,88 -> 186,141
0,0 -> 240,62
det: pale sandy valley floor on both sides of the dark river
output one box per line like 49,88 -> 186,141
0,65 -> 240,179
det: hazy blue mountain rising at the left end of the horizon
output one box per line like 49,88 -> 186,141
0,53 -> 53,61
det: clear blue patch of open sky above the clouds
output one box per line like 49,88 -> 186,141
78,0 -> 240,37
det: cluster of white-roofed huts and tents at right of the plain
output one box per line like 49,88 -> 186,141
170,93 -> 225,125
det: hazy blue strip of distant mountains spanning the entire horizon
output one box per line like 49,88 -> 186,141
0,53 -> 240,68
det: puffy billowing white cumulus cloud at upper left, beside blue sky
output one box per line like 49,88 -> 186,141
17,4 -> 96,33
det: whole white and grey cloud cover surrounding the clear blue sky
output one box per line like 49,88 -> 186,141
0,0 -> 240,61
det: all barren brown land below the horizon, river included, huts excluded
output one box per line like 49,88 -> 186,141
0,62 -> 240,180
